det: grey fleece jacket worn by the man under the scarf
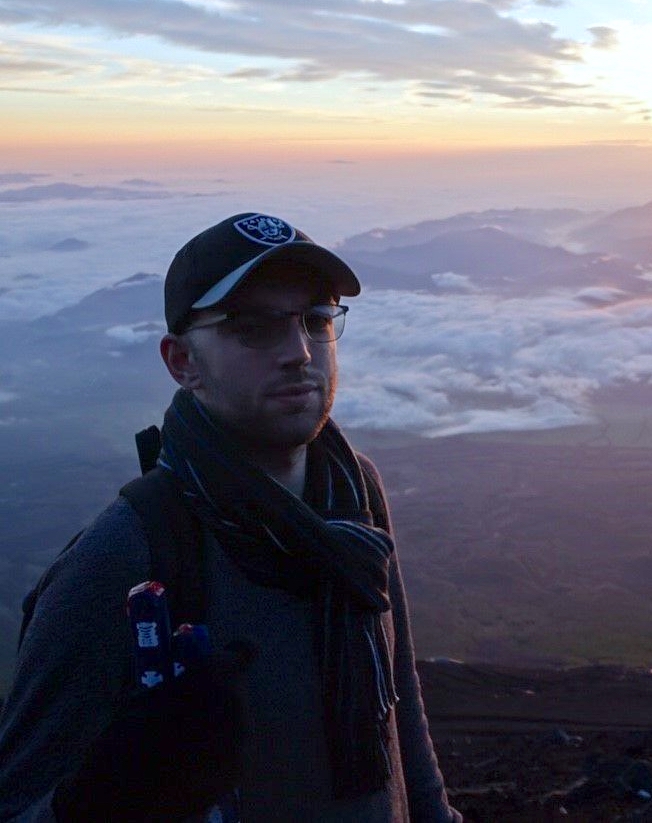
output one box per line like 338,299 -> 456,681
0,480 -> 461,823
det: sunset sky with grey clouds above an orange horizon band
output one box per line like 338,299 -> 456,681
0,0 -> 652,192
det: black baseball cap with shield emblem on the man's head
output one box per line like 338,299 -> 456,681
165,212 -> 360,334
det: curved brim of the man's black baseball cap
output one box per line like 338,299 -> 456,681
192,240 -> 360,309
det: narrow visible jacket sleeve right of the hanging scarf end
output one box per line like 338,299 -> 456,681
358,455 -> 462,823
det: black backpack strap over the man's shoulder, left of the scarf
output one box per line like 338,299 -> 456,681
120,466 -> 206,626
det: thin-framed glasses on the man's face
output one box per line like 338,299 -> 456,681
188,305 -> 349,349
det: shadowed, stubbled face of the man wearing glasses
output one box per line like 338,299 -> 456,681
182,277 -> 337,452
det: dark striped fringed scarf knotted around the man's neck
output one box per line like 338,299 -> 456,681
160,390 -> 397,797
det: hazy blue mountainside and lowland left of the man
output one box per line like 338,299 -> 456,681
0,274 -> 174,694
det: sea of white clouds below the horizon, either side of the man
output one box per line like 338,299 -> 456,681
0,186 -> 652,436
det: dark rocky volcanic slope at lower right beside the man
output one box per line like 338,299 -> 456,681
419,663 -> 652,823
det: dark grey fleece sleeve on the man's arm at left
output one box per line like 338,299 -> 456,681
0,500 -> 150,823
